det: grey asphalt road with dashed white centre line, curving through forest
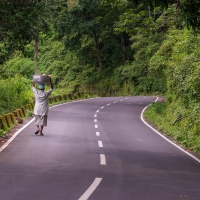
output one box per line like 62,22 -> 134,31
0,97 -> 200,200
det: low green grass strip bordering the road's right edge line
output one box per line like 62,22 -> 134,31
144,103 -> 200,153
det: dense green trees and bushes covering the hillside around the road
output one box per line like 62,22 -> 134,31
0,0 -> 200,152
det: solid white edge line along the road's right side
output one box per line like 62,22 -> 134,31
140,97 -> 200,163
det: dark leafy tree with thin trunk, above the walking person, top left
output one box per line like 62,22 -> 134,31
0,0 -> 51,71
